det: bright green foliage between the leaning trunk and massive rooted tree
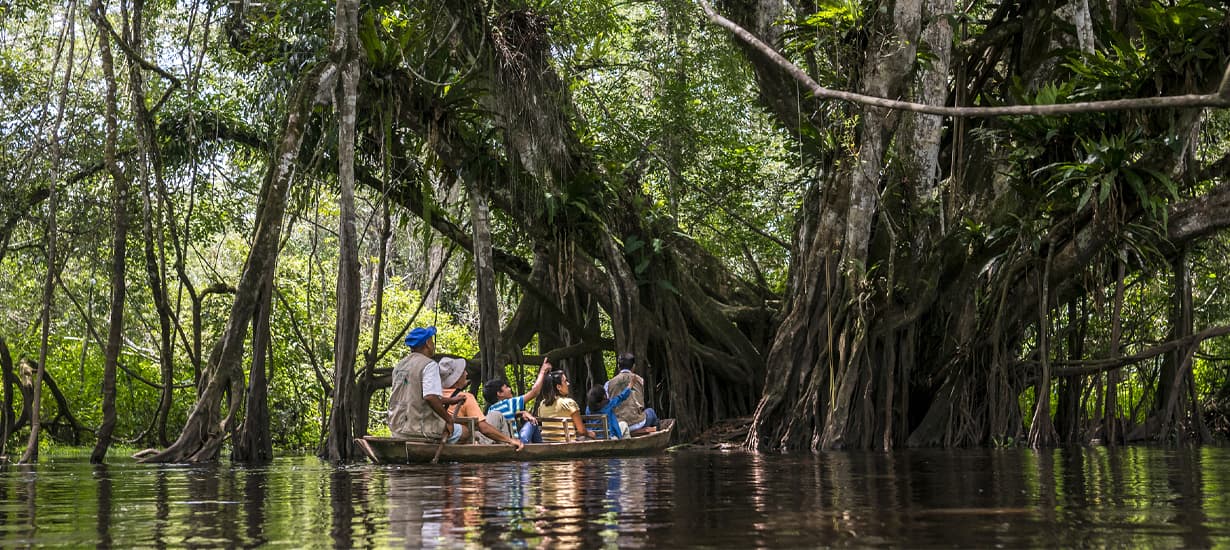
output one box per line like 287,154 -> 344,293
563,2 -> 802,292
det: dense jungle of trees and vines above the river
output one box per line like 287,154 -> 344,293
0,0 -> 1230,461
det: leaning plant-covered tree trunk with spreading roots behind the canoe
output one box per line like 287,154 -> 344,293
418,0 -> 768,437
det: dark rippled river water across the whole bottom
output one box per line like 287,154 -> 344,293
0,448 -> 1230,549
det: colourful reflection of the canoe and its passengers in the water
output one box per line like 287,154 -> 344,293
387,459 -> 672,548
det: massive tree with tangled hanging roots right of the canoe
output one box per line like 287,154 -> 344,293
706,0 -> 1220,449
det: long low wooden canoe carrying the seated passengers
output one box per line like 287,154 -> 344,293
354,418 -> 675,464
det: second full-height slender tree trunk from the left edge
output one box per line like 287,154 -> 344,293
90,1 -> 129,464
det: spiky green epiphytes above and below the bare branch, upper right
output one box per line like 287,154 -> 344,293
1010,1 -> 1225,233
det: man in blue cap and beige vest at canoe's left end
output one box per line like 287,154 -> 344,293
389,326 -> 470,443
